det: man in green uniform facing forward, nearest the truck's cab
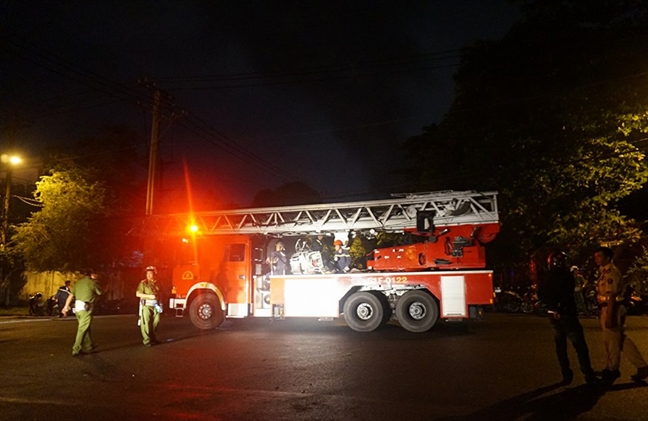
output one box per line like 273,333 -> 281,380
135,266 -> 162,346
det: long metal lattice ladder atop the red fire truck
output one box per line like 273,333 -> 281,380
139,191 -> 499,235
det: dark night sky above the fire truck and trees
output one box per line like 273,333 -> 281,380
0,0 -> 520,205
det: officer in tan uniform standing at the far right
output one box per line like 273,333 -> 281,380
594,247 -> 648,384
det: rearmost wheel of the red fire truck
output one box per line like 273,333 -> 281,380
396,290 -> 439,333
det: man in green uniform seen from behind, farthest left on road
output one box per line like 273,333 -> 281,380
63,271 -> 103,357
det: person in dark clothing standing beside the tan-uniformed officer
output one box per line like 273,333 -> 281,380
538,252 -> 597,385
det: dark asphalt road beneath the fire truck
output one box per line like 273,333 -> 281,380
0,313 -> 648,421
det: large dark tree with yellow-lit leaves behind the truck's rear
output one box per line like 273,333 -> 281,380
405,1 -> 648,270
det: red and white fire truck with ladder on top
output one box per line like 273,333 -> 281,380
150,191 -> 499,332
